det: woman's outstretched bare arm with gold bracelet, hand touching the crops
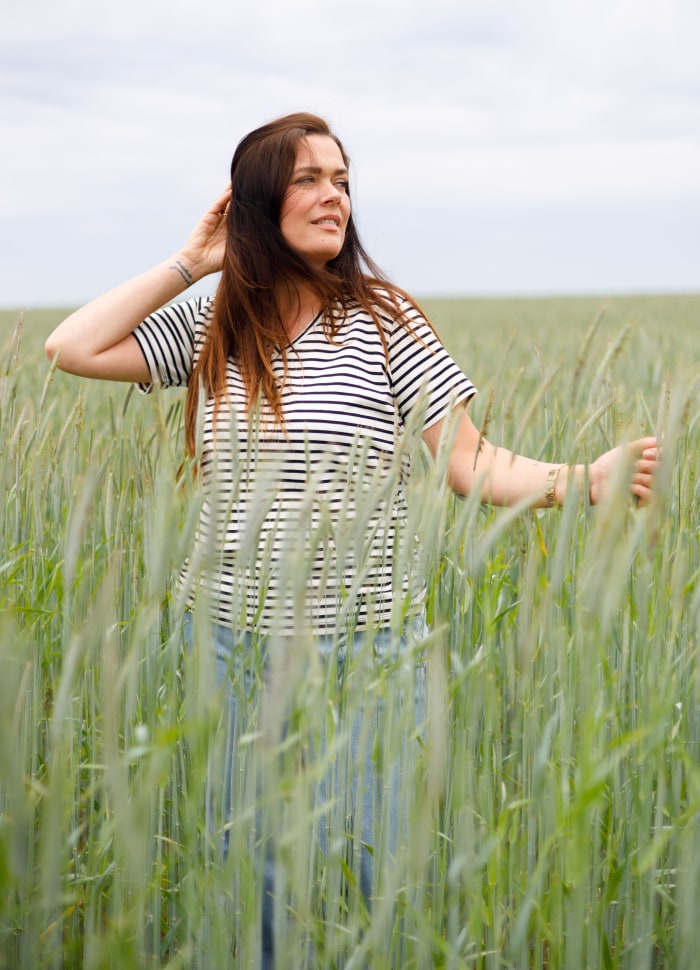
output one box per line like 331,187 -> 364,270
423,408 -> 658,508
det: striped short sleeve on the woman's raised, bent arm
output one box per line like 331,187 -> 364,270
129,297 -> 213,394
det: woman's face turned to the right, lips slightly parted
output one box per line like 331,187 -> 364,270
280,135 -> 350,267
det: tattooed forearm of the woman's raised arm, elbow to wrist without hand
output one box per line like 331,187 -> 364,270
45,253 -> 196,376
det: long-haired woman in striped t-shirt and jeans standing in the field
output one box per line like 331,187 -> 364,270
46,114 -> 657,960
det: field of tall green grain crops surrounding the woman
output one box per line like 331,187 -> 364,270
0,296 -> 700,970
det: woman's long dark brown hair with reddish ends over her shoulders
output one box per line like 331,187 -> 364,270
185,113 -> 418,454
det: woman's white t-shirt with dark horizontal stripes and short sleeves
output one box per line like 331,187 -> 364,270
134,297 -> 475,635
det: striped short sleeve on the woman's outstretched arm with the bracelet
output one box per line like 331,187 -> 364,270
389,298 -> 476,429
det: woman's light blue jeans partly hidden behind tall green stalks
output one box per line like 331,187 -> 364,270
185,614 -> 428,968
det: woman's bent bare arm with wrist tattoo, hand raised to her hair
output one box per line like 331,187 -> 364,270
45,187 -> 231,381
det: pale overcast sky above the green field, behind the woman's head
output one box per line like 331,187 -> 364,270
0,0 -> 700,307
